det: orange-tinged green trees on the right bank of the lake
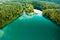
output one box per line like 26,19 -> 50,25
43,9 -> 60,25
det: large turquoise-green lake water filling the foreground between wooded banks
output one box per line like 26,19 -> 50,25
0,15 -> 60,40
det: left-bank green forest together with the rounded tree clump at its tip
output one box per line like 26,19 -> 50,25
0,2 -> 34,28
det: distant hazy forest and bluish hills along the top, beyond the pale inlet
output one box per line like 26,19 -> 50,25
10,0 -> 60,10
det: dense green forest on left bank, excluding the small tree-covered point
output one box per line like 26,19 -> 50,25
0,2 -> 23,28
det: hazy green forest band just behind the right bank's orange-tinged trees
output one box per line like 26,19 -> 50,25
31,1 -> 60,10
